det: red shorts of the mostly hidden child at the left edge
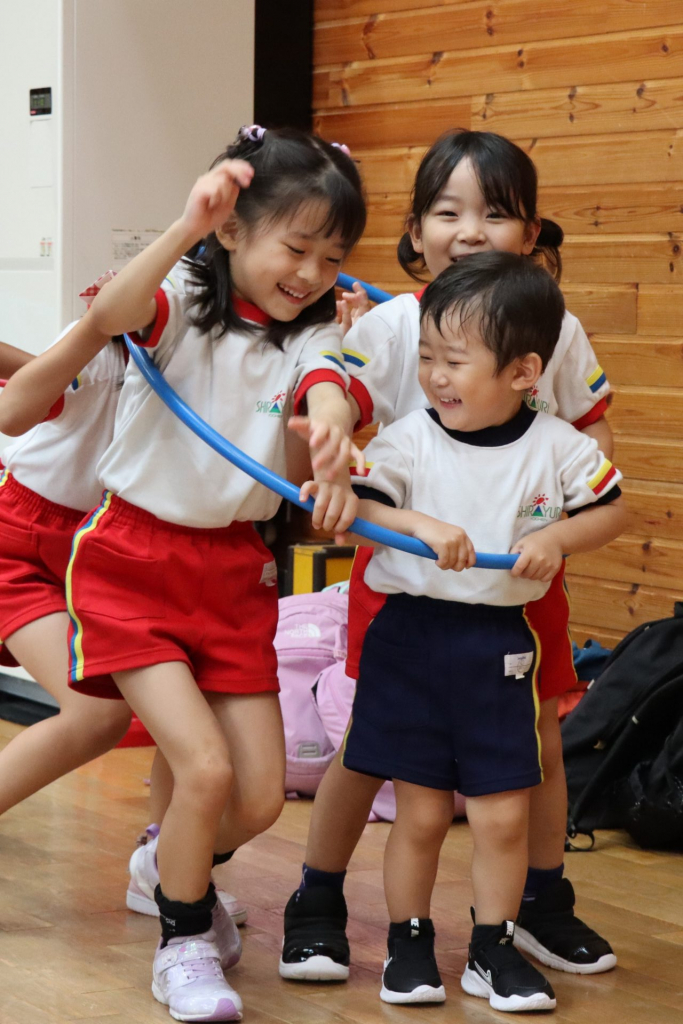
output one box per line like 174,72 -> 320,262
0,470 -> 83,666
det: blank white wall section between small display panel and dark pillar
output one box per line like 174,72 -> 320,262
62,0 -> 254,322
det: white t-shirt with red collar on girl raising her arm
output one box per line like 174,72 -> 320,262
97,260 -> 348,528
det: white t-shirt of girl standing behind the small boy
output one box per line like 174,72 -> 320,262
343,294 -> 609,428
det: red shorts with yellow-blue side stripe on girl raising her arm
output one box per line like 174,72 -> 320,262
67,490 -> 280,697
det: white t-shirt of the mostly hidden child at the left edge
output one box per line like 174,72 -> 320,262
2,322 -> 128,512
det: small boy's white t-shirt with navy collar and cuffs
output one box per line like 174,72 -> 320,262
354,406 -> 622,605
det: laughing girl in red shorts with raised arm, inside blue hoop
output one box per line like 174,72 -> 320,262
2,126 -> 366,1021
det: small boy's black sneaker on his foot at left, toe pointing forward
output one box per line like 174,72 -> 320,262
380,918 -> 445,1002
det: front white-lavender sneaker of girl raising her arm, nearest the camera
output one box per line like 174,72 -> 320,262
152,931 -> 242,1021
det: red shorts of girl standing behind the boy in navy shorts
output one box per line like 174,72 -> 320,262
346,547 -> 577,700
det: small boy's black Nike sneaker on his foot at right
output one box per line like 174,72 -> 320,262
461,921 -> 557,1013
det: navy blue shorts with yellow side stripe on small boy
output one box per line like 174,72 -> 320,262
343,594 -> 542,797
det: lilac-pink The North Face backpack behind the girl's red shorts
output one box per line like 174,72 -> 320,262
274,590 -> 348,797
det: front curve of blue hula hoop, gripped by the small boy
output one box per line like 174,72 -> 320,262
124,334 -> 518,569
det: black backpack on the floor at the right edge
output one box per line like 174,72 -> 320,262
562,602 -> 683,850
